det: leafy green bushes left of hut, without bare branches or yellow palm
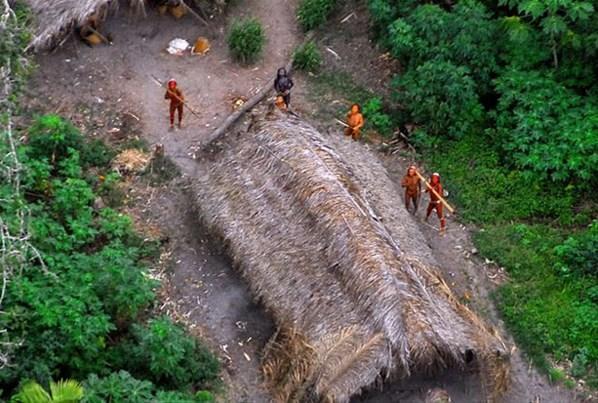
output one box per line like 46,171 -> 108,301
0,116 -> 218,402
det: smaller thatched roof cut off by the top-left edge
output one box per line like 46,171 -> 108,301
26,0 -> 145,50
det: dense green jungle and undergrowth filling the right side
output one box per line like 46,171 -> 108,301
368,0 -> 598,388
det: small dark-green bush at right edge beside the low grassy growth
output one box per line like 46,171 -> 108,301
554,221 -> 598,280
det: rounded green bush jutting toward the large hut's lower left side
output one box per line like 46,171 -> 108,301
119,317 -> 220,388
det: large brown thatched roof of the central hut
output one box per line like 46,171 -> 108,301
194,112 -> 508,402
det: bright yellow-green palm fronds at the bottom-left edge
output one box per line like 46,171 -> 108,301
11,379 -> 84,403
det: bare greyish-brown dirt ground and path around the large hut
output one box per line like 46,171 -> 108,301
28,0 -> 588,403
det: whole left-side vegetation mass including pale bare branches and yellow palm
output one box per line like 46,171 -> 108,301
0,3 -> 219,403
